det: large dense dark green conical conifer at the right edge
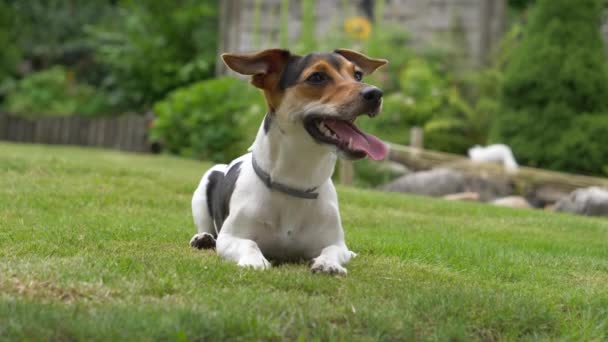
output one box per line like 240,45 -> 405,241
492,0 -> 608,173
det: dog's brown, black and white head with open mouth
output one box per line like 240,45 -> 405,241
222,49 -> 387,160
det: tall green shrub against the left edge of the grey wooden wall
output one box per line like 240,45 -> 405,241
88,0 -> 218,110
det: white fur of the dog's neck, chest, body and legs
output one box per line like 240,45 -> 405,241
192,112 -> 355,274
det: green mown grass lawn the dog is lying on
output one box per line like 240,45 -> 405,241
0,143 -> 608,341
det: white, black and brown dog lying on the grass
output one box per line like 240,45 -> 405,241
190,49 -> 388,274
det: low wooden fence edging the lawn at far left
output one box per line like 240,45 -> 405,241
0,113 -> 150,152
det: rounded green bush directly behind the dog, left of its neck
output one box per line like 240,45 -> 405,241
151,77 -> 266,162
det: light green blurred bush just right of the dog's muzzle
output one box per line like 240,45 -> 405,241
362,58 -> 498,153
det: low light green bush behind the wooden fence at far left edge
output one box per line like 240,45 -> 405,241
3,66 -> 109,117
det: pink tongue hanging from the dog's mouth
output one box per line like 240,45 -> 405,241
325,120 -> 388,160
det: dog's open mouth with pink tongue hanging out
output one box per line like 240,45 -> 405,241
304,115 -> 388,160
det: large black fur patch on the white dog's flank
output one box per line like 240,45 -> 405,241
207,162 -> 241,238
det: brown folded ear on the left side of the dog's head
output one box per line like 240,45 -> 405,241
222,49 -> 291,89
